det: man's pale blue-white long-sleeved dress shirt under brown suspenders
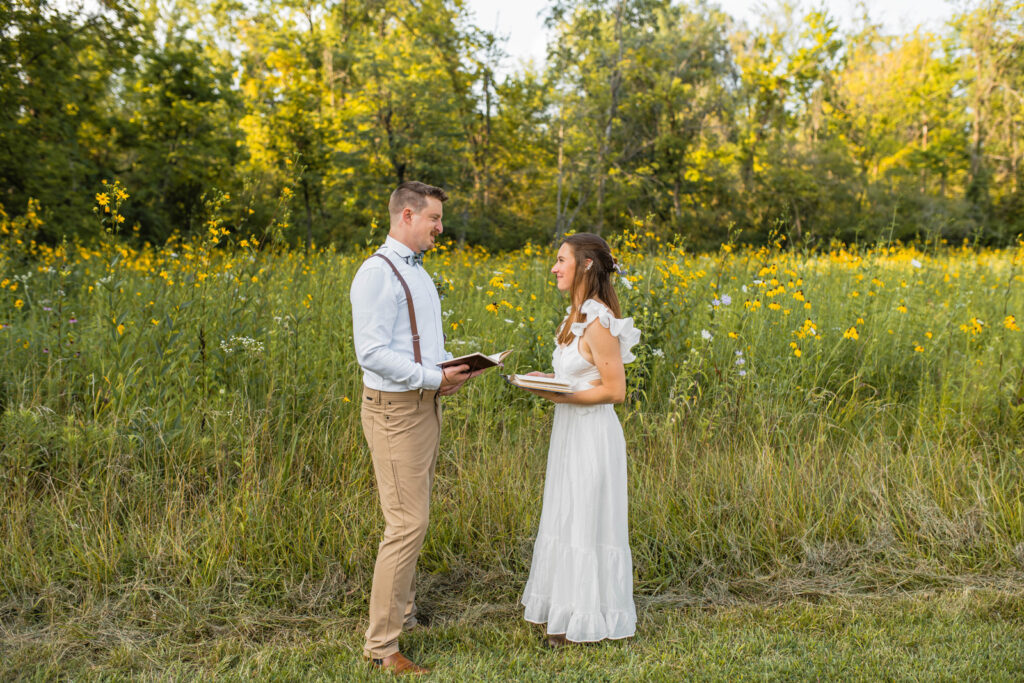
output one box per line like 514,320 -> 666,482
349,236 -> 453,391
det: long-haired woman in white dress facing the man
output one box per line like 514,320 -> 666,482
522,232 -> 640,646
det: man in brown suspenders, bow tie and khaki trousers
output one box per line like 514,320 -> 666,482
350,182 -> 479,674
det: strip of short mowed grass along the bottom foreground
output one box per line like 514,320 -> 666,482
0,589 -> 1024,681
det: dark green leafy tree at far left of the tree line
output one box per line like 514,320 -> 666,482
0,0 -> 139,238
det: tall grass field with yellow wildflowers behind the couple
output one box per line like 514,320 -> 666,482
0,198 -> 1024,679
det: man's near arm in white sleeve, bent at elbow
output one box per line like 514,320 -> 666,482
349,259 -> 444,389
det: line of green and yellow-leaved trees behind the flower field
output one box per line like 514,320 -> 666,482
0,0 -> 1024,248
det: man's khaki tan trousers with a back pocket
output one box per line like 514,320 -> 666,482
361,387 -> 441,658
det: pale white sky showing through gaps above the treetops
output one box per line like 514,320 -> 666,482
466,0 -> 954,72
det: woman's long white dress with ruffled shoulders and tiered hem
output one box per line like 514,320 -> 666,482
522,299 -> 640,642
